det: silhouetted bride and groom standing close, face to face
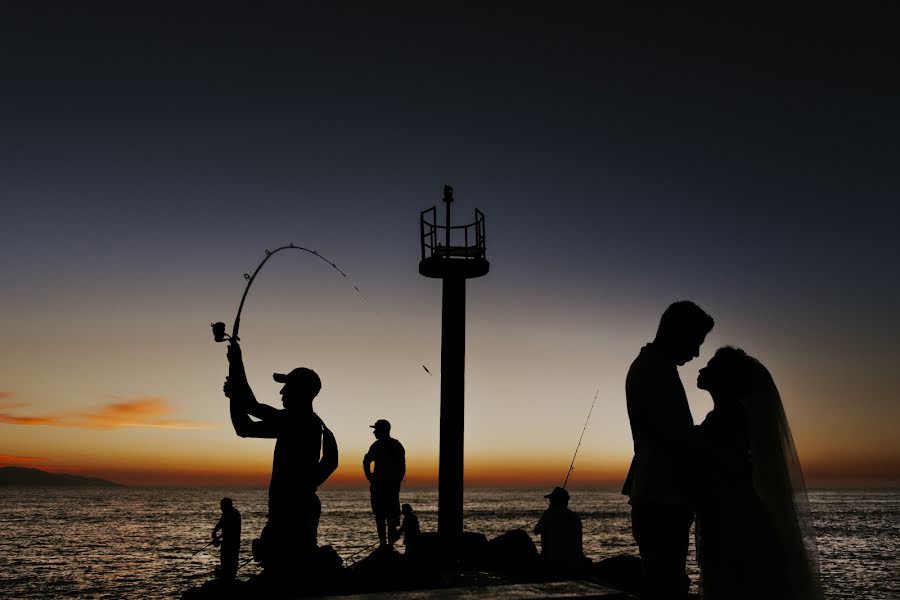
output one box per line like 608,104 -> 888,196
622,301 -> 822,600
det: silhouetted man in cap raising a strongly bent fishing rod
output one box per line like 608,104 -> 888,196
223,343 -> 338,574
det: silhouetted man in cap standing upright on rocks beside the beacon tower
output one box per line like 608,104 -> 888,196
363,419 -> 406,548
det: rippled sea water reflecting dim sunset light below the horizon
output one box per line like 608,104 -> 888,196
0,488 -> 900,600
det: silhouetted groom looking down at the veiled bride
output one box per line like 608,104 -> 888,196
622,301 -> 715,600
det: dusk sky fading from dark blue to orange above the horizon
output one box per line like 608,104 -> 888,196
0,2 -> 900,486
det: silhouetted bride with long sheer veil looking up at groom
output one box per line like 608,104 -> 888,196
696,347 -> 823,600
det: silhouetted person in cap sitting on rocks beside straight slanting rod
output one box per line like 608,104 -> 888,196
534,487 -> 590,573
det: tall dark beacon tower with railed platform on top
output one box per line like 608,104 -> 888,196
419,185 -> 490,544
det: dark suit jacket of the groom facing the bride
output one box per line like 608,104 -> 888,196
622,343 -> 696,506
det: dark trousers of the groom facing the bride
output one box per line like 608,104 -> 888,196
631,502 -> 694,600
